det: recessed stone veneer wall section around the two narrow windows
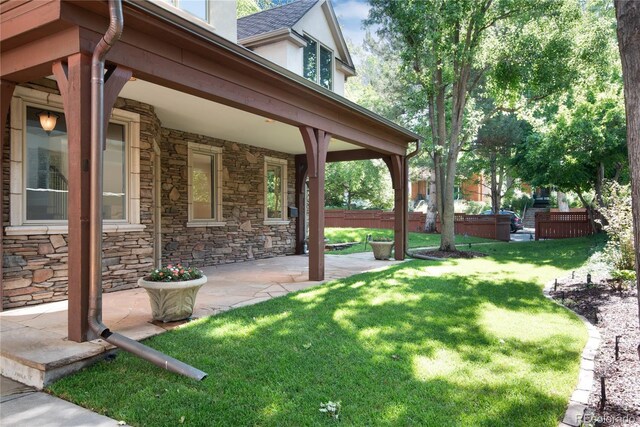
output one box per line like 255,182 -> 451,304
161,129 -> 295,267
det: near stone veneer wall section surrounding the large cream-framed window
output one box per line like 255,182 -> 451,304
2,86 -> 160,308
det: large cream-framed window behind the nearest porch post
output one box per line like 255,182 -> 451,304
5,87 -> 144,235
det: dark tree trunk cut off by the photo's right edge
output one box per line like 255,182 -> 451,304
615,0 -> 640,330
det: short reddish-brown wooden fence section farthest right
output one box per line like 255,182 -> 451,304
536,212 -> 593,240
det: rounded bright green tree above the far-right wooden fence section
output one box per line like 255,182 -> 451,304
514,91 -> 628,210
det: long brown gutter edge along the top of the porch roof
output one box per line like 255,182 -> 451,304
114,0 -> 422,143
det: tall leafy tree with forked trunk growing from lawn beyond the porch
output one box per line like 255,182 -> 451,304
368,0 -> 575,251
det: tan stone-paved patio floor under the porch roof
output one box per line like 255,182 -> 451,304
0,252 -> 397,388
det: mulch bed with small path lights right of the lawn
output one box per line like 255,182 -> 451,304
551,272 -> 640,426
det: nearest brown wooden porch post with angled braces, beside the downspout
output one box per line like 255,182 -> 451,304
53,53 -> 131,342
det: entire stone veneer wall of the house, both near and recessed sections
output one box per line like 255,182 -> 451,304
1,86 -> 295,308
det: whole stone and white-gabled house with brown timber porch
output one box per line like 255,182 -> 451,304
0,0 -> 419,341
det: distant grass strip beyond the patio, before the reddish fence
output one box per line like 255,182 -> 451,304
324,227 -> 495,255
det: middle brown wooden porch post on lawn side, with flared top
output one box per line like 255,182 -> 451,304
300,126 -> 331,280
